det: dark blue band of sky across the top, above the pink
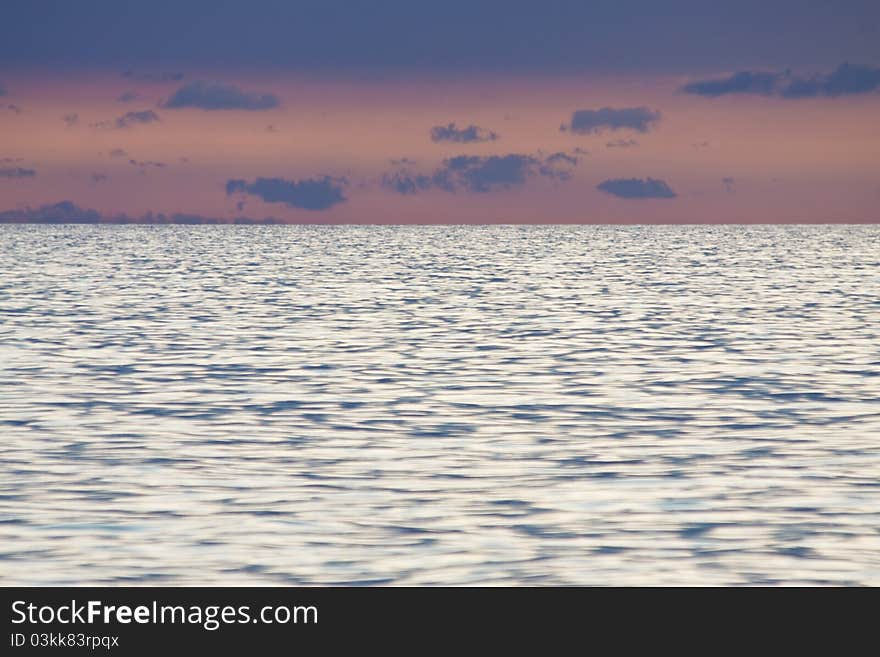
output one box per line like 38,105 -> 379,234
0,0 -> 880,74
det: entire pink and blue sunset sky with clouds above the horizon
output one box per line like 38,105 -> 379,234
0,0 -> 880,224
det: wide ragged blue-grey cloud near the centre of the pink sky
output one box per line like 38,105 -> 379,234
382,153 -> 578,196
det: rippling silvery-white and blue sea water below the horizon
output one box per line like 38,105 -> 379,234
0,225 -> 880,585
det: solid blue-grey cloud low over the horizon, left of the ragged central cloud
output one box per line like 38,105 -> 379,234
226,176 -> 348,210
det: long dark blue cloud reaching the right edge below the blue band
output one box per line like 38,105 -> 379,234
680,62 -> 880,99
